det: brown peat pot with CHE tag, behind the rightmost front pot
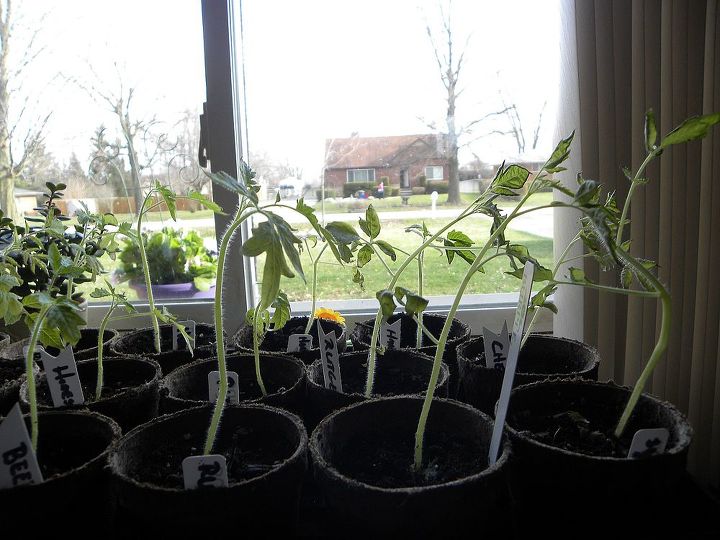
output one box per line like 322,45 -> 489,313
457,334 -> 600,417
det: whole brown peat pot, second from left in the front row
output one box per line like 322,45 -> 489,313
109,405 -> 307,538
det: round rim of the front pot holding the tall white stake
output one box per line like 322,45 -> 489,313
308,395 -> 511,495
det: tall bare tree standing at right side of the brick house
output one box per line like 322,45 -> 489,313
421,0 -> 508,204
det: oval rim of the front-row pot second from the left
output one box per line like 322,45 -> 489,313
107,403 -> 308,494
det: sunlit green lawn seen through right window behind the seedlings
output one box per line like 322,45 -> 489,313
257,218 -> 553,300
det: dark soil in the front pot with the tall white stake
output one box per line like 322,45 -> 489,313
334,433 -> 488,488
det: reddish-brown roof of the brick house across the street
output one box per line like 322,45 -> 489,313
325,133 -> 445,169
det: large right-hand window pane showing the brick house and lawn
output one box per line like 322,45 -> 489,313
240,0 -> 558,306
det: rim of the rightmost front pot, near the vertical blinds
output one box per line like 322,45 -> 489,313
505,377 -> 693,463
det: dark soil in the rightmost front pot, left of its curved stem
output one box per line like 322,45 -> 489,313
514,411 -> 632,458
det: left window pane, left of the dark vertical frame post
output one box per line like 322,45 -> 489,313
9,0 -> 217,303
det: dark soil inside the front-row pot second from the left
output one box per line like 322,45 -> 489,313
133,427 -> 297,489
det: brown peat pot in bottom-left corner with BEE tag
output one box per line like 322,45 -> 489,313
0,410 -> 120,539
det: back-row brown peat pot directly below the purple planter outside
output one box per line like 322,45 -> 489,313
110,323 -> 216,375
